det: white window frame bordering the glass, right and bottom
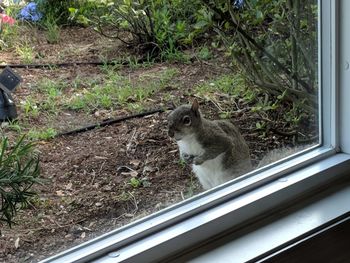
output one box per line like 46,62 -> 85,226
42,0 -> 350,263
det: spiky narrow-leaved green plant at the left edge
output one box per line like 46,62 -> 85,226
0,137 -> 40,226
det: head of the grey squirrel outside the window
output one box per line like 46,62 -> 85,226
168,100 -> 201,141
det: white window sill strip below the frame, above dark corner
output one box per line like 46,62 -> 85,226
174,168 -> 350,263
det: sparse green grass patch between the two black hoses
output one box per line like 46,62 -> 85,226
10,66 -> 179,140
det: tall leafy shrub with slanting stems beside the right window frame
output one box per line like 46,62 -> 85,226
202,0 -> 317,110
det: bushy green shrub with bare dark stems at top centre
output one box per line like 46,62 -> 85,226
91,0 -> 211,57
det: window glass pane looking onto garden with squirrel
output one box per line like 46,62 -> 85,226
0,0 -> 319,262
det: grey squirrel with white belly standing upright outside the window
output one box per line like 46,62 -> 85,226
167,100 -> 253,190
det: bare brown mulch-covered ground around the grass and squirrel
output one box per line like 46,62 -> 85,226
0,28 -> 313,262
